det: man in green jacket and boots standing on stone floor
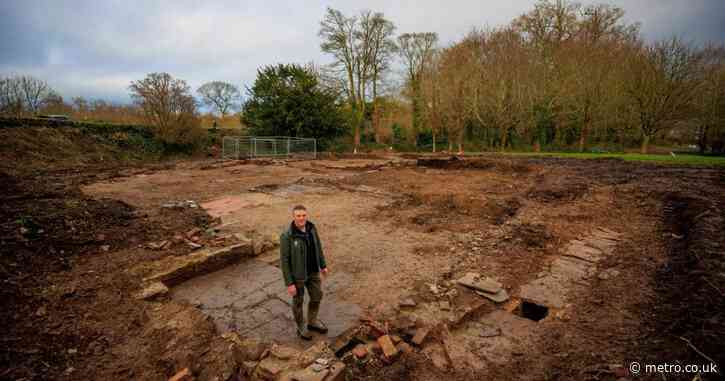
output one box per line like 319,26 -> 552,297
279,205 -> 329,340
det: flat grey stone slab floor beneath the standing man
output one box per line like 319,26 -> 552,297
171,259 -> 360,347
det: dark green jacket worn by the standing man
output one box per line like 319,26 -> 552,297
279,221 -> 327,286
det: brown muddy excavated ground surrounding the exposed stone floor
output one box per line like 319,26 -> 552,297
0,155 -> 725,380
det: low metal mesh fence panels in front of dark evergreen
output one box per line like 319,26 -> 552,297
222,136 -> 317,160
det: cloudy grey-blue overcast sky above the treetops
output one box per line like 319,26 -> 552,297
0,0 -> 725,102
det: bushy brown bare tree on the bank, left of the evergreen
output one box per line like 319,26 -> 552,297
129,73 -> 199,144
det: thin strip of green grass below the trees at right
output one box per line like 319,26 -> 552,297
480,152 -> 725,167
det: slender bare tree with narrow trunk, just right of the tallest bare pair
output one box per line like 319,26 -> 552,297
398,33 -> 438,144
